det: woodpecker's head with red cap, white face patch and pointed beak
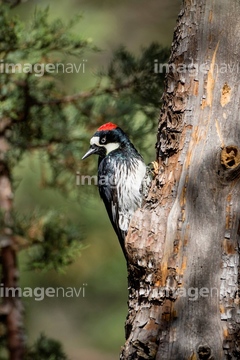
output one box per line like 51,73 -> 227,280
82,123 -> 129,159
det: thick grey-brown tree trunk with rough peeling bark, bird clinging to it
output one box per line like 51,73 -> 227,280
120,0 -> 240,360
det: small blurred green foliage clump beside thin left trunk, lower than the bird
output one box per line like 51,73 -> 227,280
13,210 -> 83,271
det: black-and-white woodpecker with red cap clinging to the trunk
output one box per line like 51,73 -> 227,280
82,122 -> 151,259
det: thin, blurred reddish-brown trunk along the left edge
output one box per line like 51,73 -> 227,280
0,118 -> 24,360
